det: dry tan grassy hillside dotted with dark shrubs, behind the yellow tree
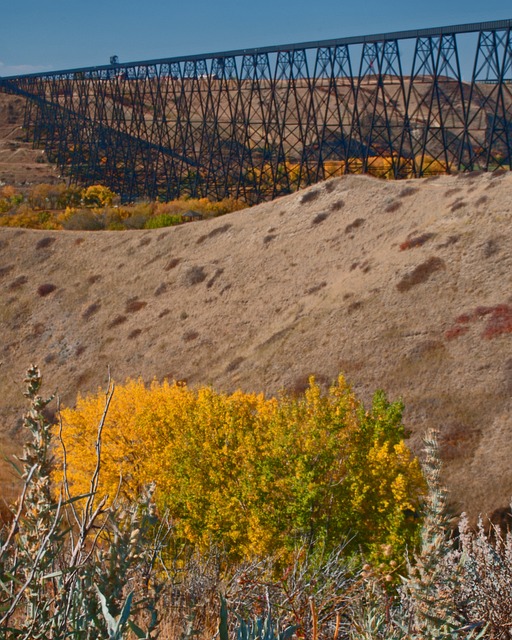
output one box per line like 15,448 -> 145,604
0,168 -> 512,514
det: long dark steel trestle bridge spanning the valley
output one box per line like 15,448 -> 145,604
0,20 -> 512,202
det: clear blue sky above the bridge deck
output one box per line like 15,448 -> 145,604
0,0 -> 512,76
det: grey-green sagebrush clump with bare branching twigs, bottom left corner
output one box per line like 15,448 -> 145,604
0,367 -> 167,640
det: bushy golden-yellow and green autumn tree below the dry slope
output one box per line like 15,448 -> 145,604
57,376 -> 424,560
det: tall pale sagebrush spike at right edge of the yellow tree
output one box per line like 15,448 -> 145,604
350,431 -> 490,640
